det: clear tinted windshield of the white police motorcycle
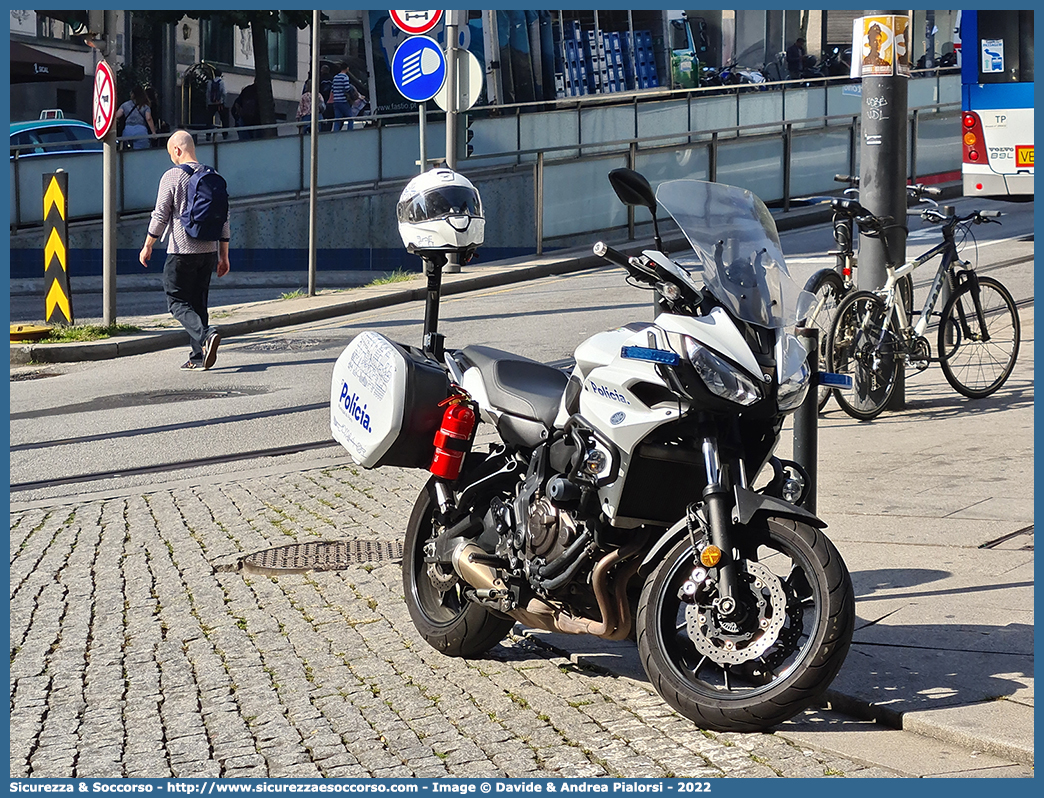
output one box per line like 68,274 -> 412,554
656,180 -> 815,329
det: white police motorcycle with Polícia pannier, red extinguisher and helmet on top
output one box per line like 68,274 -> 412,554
331,169 -> 855,731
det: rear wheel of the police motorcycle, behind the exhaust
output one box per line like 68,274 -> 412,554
402,484 -> 515,657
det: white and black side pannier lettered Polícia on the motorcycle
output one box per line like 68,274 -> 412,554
330,330 -> 450,468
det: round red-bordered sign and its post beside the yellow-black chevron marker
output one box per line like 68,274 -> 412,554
92,58 -> 116,327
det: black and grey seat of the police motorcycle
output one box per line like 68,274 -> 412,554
461,346 -> 569,428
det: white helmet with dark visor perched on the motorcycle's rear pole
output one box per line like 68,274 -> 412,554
396,169 -> 485,252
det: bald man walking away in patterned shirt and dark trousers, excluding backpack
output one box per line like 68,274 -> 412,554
138,131 -> 231,371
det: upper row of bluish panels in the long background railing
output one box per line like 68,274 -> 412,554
10,73 -> 959,235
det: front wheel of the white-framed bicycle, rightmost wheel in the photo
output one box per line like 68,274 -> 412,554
939,277 -> 1020,399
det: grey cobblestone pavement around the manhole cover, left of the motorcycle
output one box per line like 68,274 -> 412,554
10,466 -> 897,778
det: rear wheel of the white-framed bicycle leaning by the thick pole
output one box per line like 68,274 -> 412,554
827,291 -> 900,421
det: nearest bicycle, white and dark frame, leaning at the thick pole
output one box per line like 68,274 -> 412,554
826,201 -> 1021,421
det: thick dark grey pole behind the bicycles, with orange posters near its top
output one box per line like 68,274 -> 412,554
853,10 -> 909,409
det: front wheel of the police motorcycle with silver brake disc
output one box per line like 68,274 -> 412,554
638,518 -> 855,732
